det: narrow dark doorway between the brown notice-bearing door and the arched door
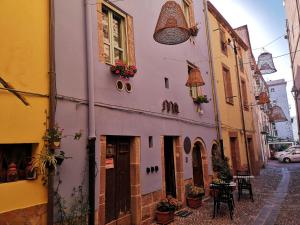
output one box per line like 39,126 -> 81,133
164,136 -> 176,198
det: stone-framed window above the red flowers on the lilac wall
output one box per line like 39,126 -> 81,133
98,2 -> 135,65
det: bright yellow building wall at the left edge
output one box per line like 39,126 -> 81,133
0,0 -> 49,214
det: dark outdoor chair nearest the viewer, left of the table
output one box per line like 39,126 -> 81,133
212,183 -> 234,219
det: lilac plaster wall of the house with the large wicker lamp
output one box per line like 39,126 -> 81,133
55,0 -> 216,205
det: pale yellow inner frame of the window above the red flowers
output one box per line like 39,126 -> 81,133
101,2 -> 128,65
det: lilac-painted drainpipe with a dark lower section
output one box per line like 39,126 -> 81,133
85,0 -> 96,225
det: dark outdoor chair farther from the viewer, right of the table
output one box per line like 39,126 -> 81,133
237,170 -> 254,202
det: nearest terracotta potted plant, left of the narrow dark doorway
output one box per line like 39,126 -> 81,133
156,198 -> 176,224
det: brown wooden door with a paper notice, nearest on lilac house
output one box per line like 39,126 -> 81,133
105,136 -> 130,223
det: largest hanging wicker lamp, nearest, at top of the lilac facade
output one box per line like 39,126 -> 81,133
153,1 -> 190,45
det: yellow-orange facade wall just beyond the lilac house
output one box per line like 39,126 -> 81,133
208,12 -> 253,171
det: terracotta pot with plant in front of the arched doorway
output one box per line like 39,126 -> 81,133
186,184 -> 205,209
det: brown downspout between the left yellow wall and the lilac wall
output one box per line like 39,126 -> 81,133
47,0 -> 56,225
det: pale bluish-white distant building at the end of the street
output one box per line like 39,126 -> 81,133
267,79 -> 294,140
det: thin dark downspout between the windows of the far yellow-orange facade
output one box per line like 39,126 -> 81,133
233,39 -> 252,174
